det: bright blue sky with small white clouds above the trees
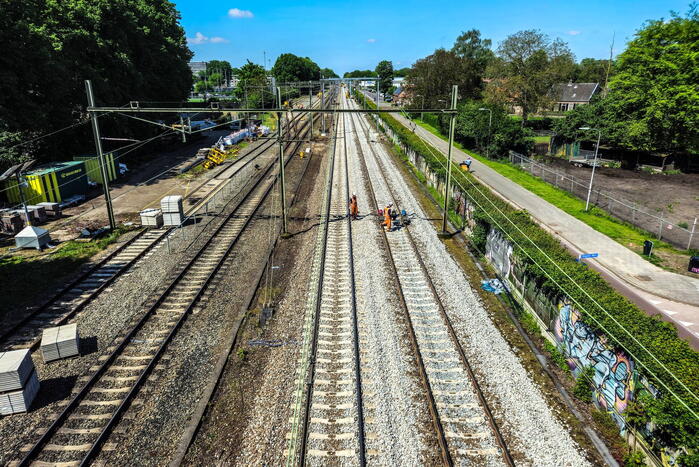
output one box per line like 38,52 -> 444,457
174,0 -> 689,75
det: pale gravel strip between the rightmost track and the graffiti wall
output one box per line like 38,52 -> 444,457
366,109 -> 588,466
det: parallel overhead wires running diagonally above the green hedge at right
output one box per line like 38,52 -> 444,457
360,90 -> 699,419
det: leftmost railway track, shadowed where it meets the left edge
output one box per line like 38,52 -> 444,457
0,98 -> 318,351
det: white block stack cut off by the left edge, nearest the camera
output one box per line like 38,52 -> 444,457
0,349 -> 39,415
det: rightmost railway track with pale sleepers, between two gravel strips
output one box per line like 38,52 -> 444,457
343,93 -> 514,465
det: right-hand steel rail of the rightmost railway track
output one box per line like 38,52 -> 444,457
348,96 -> 515,467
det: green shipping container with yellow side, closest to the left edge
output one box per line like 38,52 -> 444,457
5,161 -> 88,204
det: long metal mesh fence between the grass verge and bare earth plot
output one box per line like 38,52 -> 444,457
510,151 -> 699,249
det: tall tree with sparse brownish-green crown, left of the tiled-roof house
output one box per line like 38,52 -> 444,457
487,30 -> 575,120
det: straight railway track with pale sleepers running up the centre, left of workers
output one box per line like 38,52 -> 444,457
287,101 -> 366,465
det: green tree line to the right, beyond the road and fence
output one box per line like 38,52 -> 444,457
370,6 -> 699,156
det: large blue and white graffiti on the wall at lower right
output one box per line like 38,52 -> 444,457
553,303 -> 634,431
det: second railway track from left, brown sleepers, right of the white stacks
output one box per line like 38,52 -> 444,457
11,94 -> 330,465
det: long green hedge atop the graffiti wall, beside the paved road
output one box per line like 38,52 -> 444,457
357,89 -> 699,449
